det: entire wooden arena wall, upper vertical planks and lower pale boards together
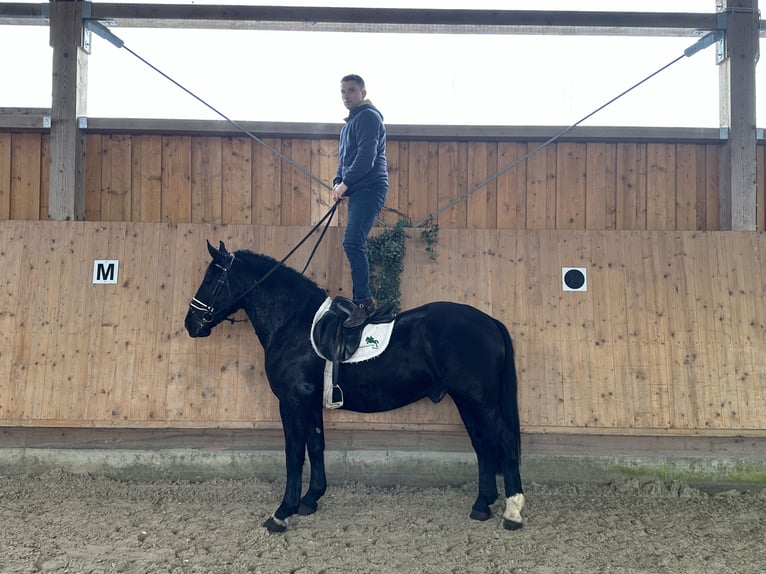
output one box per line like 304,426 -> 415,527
0,127 -> 766,486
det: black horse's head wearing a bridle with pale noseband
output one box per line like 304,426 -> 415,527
184,241 -> 238,337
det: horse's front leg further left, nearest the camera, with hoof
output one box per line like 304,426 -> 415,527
263,401 -> 308,532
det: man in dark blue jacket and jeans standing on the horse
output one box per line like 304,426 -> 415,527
332,74 -> 388,327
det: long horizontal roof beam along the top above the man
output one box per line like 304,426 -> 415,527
0,2 -> 720,36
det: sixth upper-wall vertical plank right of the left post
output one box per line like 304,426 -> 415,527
221,137 -> 252,225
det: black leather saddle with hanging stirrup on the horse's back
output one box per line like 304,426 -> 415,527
311,297 -> 396,408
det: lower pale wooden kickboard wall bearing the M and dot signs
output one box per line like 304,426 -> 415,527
0,221 -> 766,436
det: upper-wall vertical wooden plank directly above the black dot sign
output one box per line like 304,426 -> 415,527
556,142 -> 587,229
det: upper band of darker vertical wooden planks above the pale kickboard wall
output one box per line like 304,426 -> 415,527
0,132 -> 766,230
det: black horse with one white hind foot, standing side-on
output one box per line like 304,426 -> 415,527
185,242 -> 524,532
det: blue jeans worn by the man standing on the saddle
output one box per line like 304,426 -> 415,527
343,186 -> 388,302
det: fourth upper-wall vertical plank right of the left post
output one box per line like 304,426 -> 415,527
162,136 -> 192,223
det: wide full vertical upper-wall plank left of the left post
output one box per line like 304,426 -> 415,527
10,133 -> 42,221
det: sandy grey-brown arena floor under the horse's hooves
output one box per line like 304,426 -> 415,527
0,473 -> 766,574
